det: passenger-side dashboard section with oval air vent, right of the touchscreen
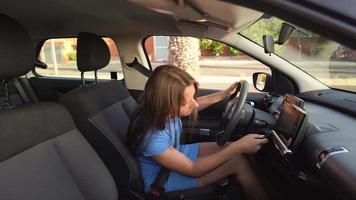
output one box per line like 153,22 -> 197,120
303,103 -> 356,199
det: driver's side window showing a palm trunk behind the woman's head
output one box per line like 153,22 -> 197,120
144,36 -> 271,92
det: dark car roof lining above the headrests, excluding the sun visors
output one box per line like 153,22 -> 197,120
0,0 -> 177,38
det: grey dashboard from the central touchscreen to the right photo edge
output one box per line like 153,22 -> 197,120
265,95 -> 356,199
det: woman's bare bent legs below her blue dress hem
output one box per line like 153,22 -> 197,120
198,142 -> 266,200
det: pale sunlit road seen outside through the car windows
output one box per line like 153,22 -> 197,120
37,59 -> 356,91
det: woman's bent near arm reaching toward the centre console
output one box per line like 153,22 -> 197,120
152,134 -> 268,177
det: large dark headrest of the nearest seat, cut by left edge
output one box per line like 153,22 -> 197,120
0,14 -> 35,80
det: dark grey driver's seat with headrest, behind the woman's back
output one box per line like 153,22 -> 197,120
60,33 -> 239,199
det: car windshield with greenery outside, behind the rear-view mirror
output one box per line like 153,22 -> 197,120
240,17 -> 356,92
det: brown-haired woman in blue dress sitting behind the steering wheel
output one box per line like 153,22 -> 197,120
128,65 -> 268,199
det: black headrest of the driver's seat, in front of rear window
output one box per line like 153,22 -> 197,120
77,32 -> 110,72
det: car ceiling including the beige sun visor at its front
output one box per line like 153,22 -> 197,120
0,0 -> 262,39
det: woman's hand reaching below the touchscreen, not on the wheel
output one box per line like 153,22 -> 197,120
231,134 -> 268,154
